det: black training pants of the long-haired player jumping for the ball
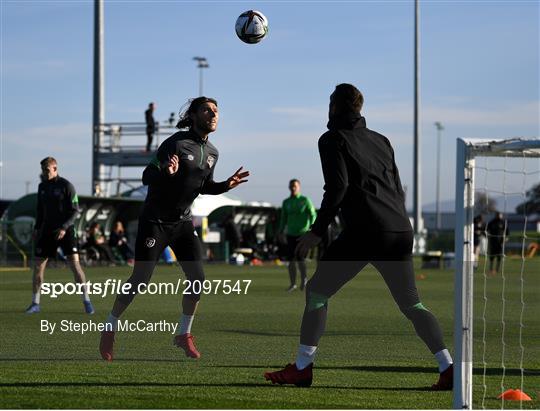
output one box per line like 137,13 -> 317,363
118,217 -> 204,305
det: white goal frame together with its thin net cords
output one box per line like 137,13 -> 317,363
453,138 -> 540,409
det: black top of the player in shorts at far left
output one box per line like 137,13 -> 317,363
35,176 -> 79,231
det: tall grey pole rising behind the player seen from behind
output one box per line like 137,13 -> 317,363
413,0 -> 422,253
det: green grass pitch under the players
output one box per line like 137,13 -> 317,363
0,258 -> 540,409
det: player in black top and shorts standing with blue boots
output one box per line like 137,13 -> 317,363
26,157 -> 94,314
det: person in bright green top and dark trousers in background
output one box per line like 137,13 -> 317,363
279,178 -> 317,292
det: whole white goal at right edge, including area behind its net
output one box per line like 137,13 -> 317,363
453,138 -> 540,409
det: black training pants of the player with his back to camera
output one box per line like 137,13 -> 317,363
300,230 -> 445,353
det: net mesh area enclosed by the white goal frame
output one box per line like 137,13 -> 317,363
473,146 -> 540,409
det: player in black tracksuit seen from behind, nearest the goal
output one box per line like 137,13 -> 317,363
265,84 -> 453,390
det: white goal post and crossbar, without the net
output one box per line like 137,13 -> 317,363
453,138 -> 540,409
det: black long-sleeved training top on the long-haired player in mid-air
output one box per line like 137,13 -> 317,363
142,131 -> 228,222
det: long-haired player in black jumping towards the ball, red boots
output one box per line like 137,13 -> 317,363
100,97 -> 249,361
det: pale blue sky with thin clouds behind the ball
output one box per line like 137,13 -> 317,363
0,0 -> 540,212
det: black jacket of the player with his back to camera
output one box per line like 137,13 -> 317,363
312,116 -> 412,236
